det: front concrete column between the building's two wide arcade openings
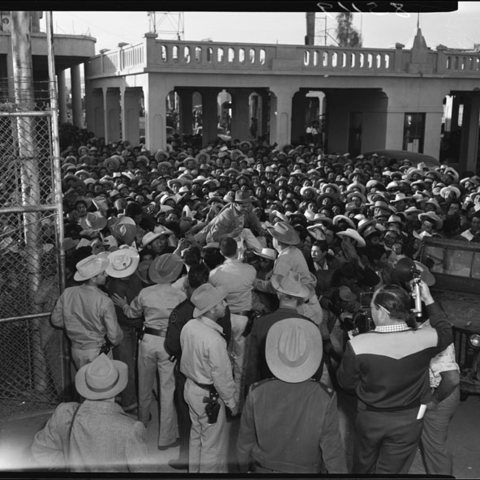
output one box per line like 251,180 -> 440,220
270,86 -> 296,148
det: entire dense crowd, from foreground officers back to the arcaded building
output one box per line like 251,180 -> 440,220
27,130 -> 480,474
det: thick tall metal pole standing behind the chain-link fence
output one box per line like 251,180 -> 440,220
11,11 -> 47,392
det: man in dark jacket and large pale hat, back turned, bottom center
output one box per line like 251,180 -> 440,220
237,318 -> 346,474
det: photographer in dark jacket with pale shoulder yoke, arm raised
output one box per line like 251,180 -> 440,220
337,278 -> 453,474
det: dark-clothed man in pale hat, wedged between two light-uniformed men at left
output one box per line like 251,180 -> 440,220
106,245 -> 143,412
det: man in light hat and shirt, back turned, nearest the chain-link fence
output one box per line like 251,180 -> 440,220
51,255 -> 123,369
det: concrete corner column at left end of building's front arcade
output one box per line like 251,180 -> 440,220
144,73 -> 174,153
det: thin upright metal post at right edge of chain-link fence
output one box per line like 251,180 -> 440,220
46,12 -> 74,397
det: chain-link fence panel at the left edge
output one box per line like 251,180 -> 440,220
0,103 -> 67,420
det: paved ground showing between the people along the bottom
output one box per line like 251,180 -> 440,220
0,397 -> 480,478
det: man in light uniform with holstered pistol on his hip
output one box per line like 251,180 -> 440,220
180,283 -> 238,473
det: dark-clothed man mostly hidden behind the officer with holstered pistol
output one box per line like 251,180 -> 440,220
165,264 -> 232,470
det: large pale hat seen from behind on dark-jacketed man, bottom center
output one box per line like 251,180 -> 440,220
265,318 -> 323,383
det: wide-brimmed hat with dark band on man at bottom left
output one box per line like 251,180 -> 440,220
75,353 -> 128,400
